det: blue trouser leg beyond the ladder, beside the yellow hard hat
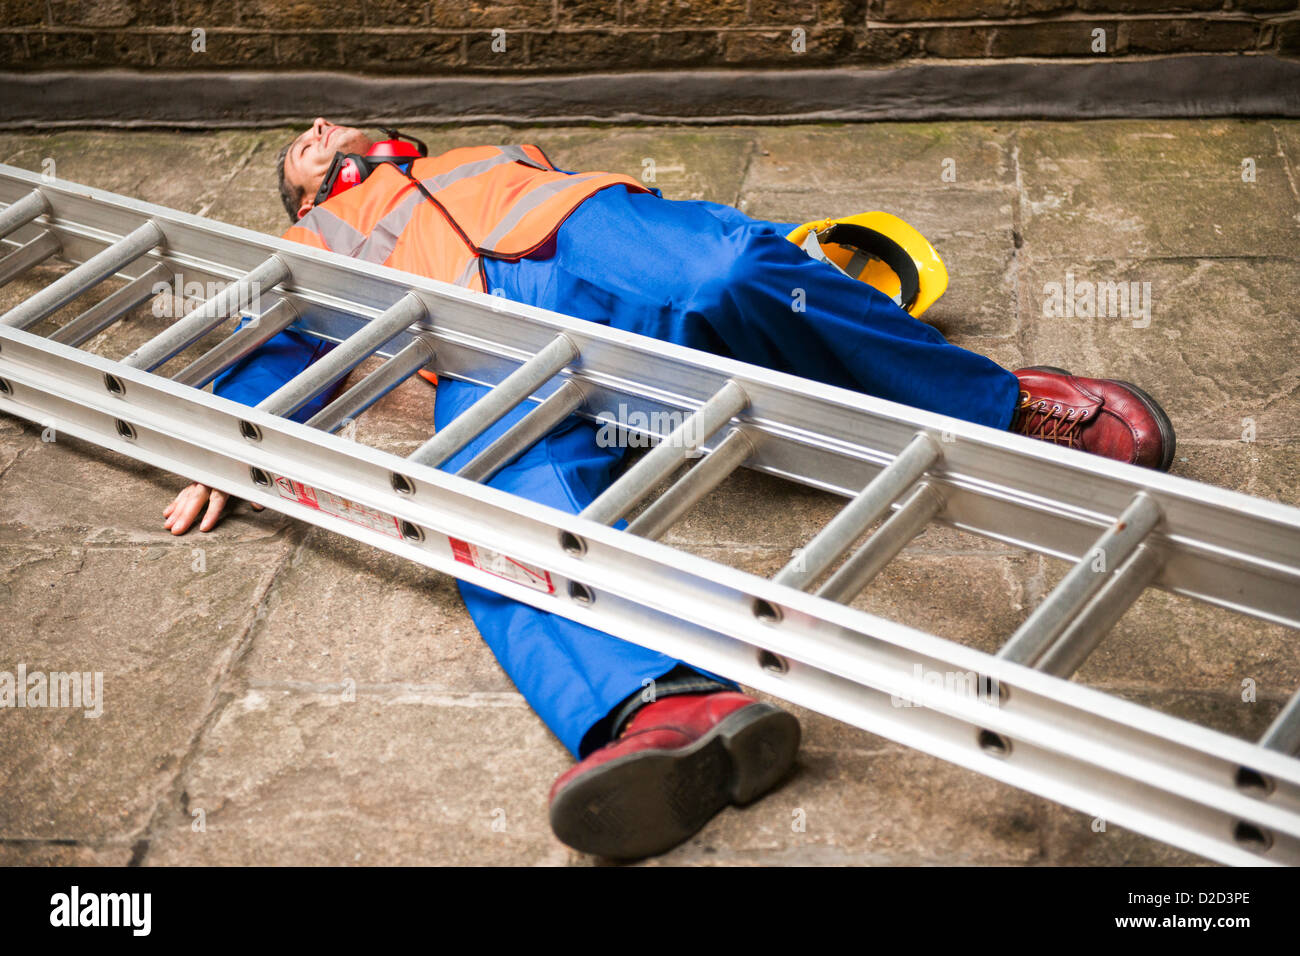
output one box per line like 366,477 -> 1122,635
486,187 -> 1019,428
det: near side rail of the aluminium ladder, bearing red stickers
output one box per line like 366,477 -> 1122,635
0,321 -> 1300,862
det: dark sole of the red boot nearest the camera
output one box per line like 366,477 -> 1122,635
550,704 -> 800,860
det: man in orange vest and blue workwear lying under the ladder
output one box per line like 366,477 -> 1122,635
164,118 -> 1174,858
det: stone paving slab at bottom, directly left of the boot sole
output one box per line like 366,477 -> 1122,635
144,685 -> 569,865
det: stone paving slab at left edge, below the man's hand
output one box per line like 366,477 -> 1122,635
0,541 -> 289,847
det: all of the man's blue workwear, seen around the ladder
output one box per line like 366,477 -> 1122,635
215,186 -> 1019,757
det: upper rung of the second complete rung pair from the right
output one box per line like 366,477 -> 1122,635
772,432 -> 940,591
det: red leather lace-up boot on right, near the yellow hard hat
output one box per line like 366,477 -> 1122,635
1011,365 -> 1175,471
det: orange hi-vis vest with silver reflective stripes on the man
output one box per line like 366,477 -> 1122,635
285,146 -> 650,293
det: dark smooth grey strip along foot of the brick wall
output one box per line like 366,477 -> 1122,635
0,55 -> 1300,129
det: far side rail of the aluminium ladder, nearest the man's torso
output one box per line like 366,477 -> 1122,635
0,168 -> 1300,626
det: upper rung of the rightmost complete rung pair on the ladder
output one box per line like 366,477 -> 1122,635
997,492 -> 1160,666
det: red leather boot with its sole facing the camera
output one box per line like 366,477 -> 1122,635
551,691 -> 800,860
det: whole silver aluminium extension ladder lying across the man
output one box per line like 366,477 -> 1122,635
0,165 -> 1300,865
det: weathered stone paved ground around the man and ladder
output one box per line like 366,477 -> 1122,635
0,120 -> 1300,865
